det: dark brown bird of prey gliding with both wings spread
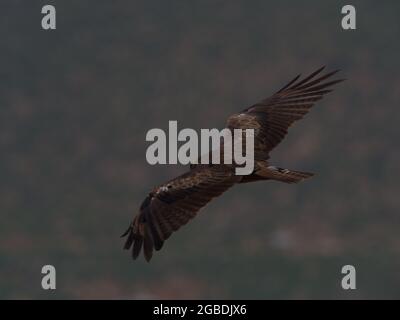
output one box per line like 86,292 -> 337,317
122,67 -> 345,261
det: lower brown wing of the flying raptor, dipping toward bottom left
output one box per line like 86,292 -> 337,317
123,165 -> 241,261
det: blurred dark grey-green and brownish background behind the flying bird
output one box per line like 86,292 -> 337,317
0,0 -> 400,299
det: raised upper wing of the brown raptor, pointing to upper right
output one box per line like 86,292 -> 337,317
227,67 -> 344,160
